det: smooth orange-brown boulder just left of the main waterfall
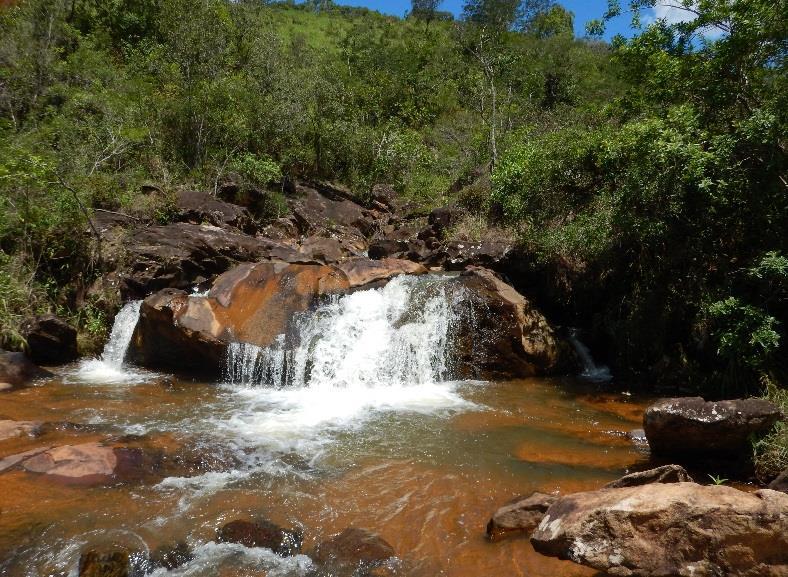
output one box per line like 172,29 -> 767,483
130,259 -> 426,375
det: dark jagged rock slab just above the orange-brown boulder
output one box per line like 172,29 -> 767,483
118,223 -> 303,298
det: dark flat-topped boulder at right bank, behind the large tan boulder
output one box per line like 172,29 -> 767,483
643,397 -> 782,459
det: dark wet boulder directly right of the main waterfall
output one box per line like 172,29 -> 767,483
456,267 -> 574,378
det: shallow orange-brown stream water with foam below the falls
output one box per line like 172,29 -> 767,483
0,365 -> 647,577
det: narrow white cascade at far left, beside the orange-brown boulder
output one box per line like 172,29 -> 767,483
76,301 -> 149,383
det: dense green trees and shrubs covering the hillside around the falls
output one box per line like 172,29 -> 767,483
0,0 -> 788,404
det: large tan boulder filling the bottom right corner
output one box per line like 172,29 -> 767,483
531,483 -> 788,577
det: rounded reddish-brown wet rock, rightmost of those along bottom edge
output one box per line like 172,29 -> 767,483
310,527 -> 395,572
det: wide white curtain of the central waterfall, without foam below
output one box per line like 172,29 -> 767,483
225,276 -> 456,389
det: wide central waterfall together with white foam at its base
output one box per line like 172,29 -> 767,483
214,276 -> 473,455
